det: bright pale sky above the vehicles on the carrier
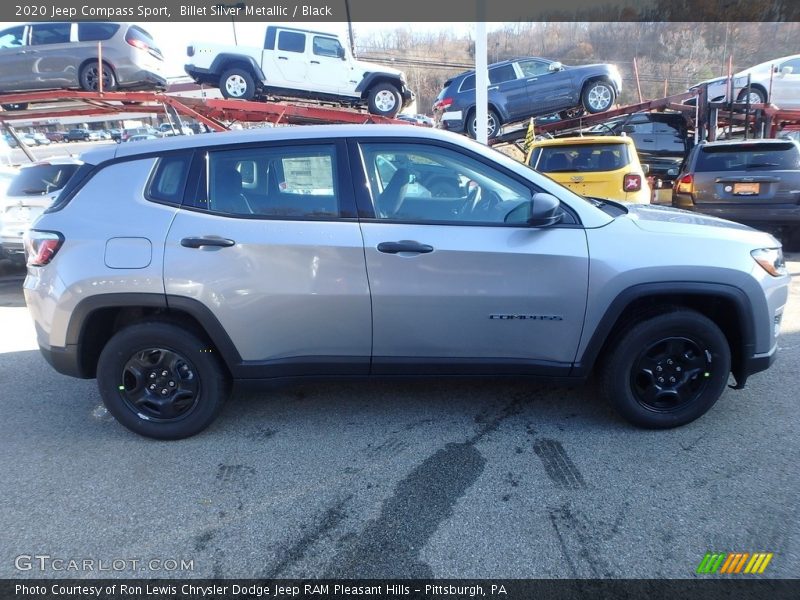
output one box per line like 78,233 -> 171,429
0,21 -> 490,77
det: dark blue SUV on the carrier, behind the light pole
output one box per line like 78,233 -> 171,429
433,58 -> 622,138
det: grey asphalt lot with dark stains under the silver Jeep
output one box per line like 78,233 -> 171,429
0,254 -> 800,578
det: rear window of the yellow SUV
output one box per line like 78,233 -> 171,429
530,144 -> 630,173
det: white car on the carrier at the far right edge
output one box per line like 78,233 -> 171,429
690,54 -> 800,109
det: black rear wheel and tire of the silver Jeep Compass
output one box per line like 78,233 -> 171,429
97,322 -> 230,440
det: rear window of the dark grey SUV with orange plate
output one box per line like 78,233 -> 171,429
695,142 -> 800,173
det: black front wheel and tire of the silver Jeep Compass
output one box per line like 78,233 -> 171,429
600,309 -> 731,429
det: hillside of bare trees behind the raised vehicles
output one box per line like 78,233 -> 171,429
355,22 -> 800,114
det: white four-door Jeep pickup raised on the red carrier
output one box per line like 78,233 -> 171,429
185,25 -> 414,116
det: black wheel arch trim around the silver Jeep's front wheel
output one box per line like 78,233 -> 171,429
570,281 -> 766,387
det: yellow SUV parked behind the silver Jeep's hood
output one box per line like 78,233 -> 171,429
525,135 -> 650,204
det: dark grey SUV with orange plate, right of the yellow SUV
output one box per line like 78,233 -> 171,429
672,139 -> 800,245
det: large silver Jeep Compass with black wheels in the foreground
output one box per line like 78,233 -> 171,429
24,125 -> 789,439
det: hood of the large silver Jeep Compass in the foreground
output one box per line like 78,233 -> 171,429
625,204 -> 780,247
